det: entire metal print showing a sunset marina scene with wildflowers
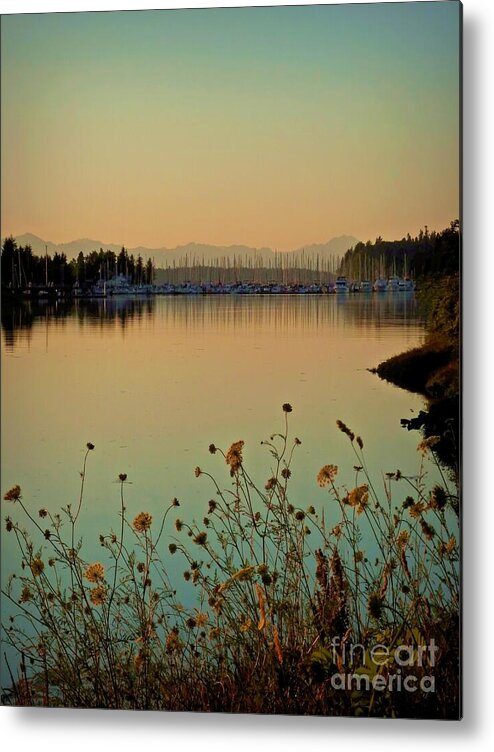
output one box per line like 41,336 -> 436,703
1,2 -> 462,720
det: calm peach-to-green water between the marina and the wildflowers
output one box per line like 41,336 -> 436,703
1,294 -> 432,684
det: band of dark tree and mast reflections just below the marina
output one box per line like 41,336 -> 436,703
2,293 -> 423,353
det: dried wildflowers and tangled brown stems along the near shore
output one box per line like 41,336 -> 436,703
3,404 -> 460,718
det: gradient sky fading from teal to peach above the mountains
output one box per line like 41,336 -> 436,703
1,1 -> 460,250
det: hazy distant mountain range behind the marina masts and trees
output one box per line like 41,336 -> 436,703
11,233 -> 359,267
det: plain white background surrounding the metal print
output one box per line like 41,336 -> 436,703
0,0 -> 494,752
